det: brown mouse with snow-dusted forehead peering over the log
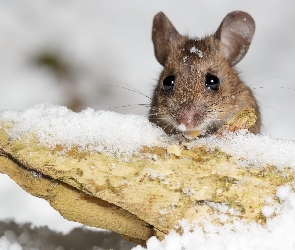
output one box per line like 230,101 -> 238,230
149,11 -> 260,136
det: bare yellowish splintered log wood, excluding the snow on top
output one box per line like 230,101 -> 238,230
0,107 -> 293,243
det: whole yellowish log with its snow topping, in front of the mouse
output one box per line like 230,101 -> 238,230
0,105 -> 295,249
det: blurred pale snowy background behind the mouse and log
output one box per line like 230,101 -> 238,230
0,0 -> 295,249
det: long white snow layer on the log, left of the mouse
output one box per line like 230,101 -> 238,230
0,104 -> 168,155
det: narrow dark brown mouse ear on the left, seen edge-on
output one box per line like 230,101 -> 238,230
152,12 -> 181,66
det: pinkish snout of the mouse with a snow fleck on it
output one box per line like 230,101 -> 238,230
177,106 -> 203,129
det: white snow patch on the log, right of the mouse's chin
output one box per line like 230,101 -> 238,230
190,130 -> 295,170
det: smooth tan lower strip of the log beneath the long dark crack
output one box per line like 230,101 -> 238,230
0,155 -> 153,243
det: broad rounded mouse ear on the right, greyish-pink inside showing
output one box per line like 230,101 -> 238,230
214,11 -> 255,66
